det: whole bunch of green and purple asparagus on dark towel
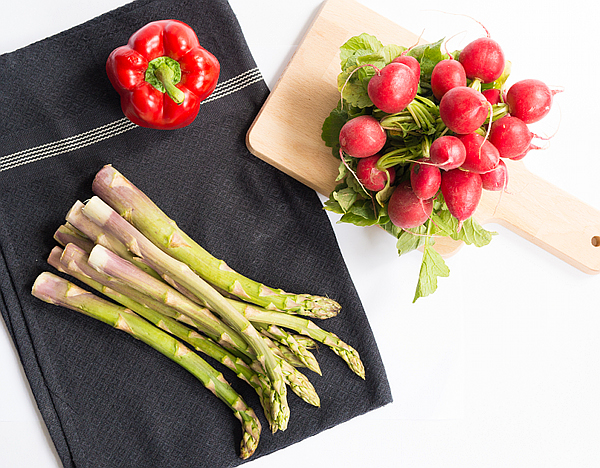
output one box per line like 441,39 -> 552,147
32,165 -> 365,458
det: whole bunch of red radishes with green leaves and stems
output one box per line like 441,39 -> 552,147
321,29 -> 556,300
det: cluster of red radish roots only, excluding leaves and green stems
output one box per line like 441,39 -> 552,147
339,36 -> 556,230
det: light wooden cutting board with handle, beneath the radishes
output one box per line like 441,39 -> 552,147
246,0 -> 600,274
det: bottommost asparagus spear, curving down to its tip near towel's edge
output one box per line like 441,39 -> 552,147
32,272 -> 260,459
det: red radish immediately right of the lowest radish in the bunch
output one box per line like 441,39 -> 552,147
441,169 -> 483,222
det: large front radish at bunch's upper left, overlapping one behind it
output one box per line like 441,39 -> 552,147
367,62 -> 419,114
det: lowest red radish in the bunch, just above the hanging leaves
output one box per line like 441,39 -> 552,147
388,181 -> 433,229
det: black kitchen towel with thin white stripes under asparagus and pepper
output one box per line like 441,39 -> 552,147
0,0 -> 391,468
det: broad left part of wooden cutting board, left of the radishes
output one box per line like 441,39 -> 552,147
246,0 -> 417,195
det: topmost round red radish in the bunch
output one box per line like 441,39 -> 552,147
458,37 -> 505,83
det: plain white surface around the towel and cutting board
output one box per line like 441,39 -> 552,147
0,0 -> 600,468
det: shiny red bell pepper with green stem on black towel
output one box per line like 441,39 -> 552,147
106,20 -> 220,130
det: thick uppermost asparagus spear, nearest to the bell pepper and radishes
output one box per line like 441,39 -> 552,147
92,166 -> 340,318
